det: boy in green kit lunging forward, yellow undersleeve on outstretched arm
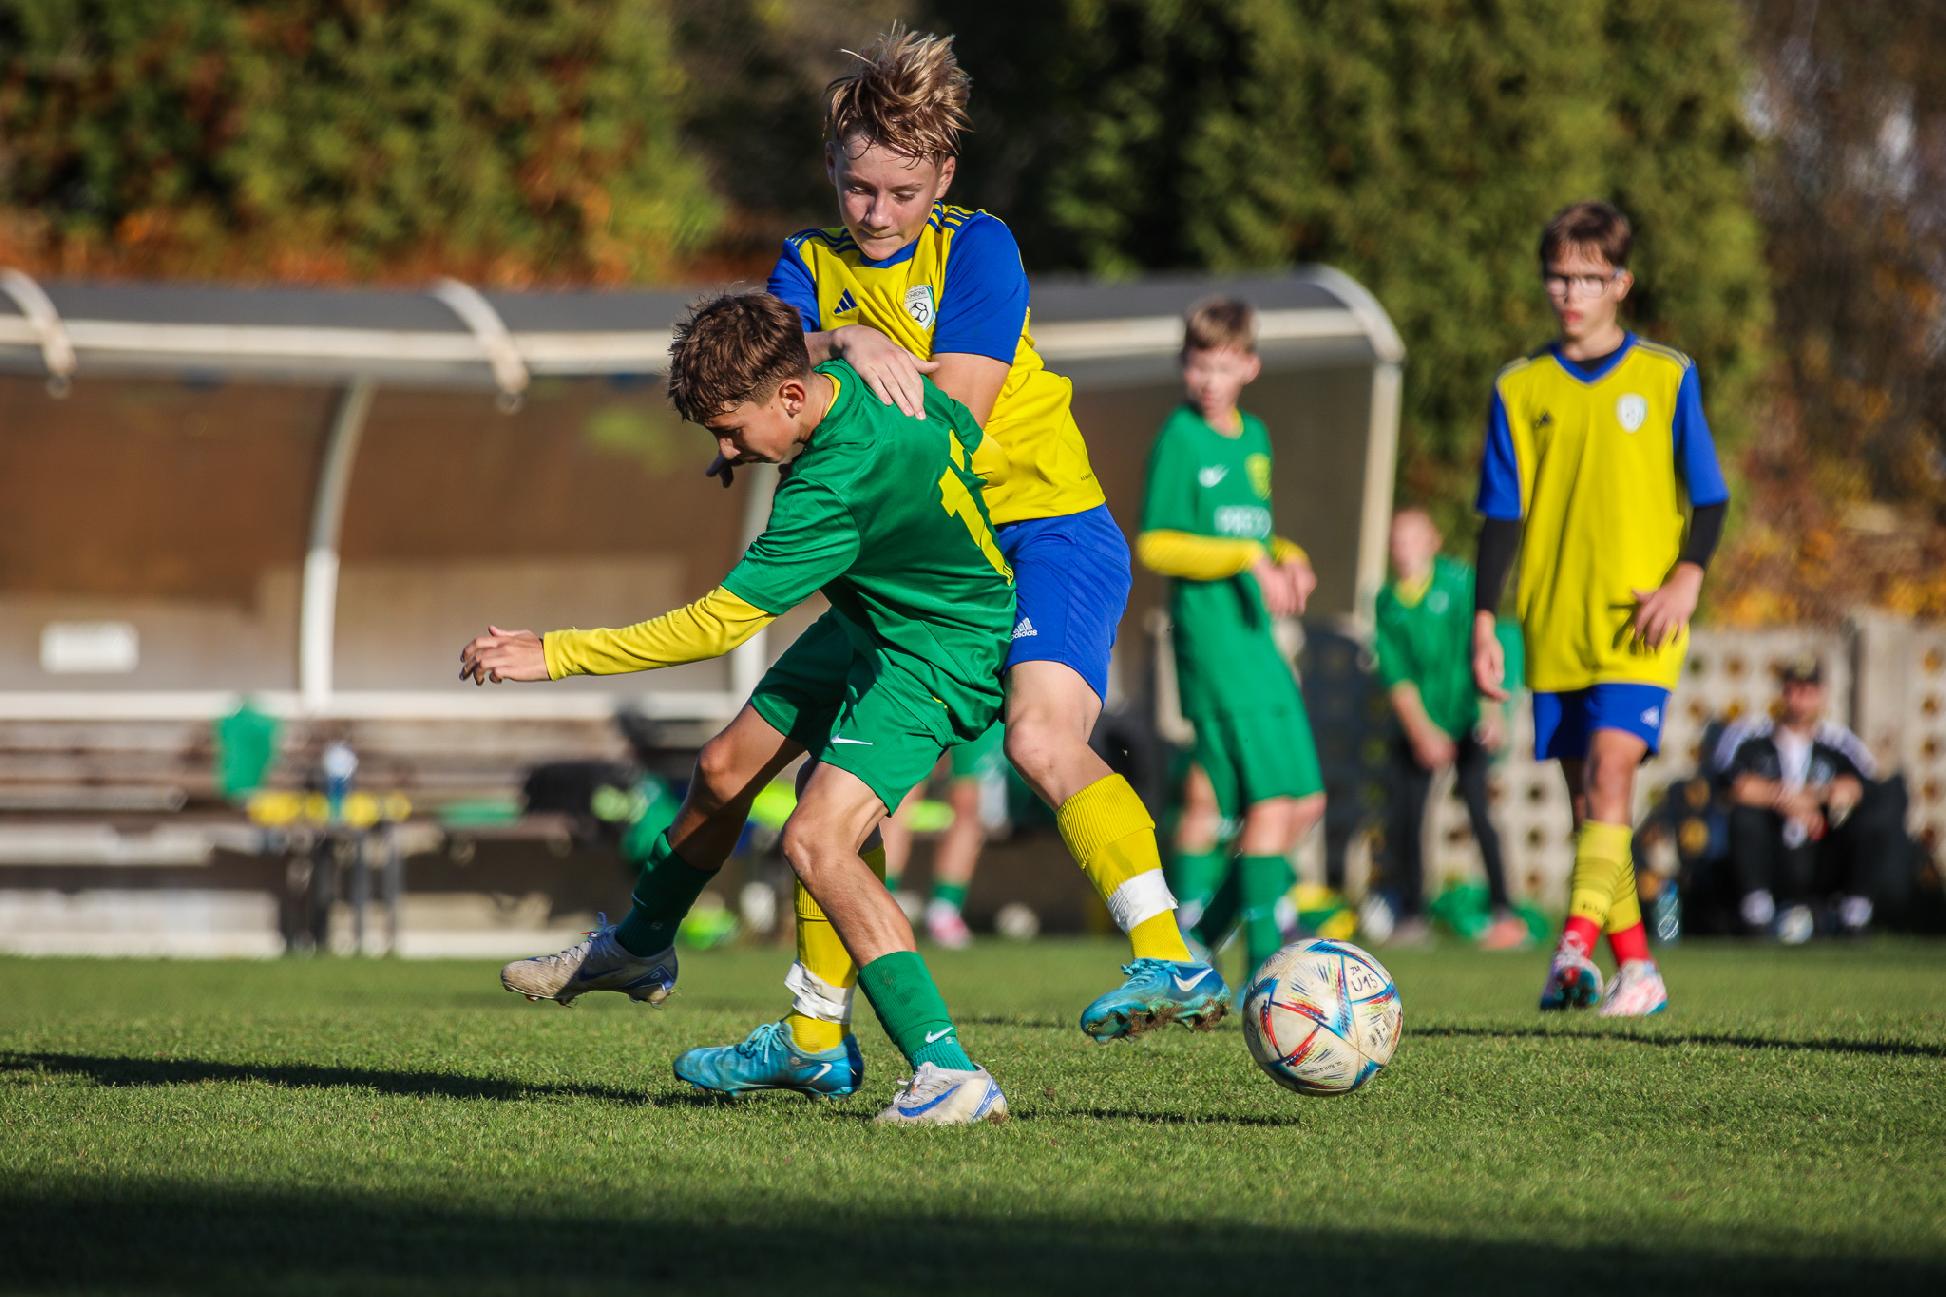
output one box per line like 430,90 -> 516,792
461,294 -> 1014,1124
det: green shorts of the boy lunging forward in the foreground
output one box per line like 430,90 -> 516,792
749,611 -> 969,812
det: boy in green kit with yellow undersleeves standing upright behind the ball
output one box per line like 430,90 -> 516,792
1136,300 -> 1325,974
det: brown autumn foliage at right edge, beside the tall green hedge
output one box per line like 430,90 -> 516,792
1718,0 -> 1946,625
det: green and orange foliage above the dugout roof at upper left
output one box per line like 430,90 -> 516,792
0,0 -> 720,284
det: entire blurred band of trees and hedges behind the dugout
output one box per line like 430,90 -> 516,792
0,0 -> 1946,621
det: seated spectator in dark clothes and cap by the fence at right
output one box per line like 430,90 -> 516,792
1714,658 -> 1903,943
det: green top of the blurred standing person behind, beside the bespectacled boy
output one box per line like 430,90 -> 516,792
1372,555 -> 1520,738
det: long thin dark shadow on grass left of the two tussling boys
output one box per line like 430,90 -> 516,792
0,1050 -> 661,1106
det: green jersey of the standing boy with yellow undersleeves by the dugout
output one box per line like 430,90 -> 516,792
1142,405 -> 1300,715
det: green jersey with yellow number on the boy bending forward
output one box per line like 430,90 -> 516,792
724,360 -> 1014,742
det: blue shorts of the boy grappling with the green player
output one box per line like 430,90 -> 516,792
994,504 -> 1133,701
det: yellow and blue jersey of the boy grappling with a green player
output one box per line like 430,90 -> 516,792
769,203 -> 1107,524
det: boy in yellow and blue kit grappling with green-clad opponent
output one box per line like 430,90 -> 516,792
675,29 -> 1228,1091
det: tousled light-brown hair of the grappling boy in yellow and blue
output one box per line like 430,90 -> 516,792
825,23 -> 973,158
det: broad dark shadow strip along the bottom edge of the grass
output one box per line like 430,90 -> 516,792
0,1184 -> 1946,1297
